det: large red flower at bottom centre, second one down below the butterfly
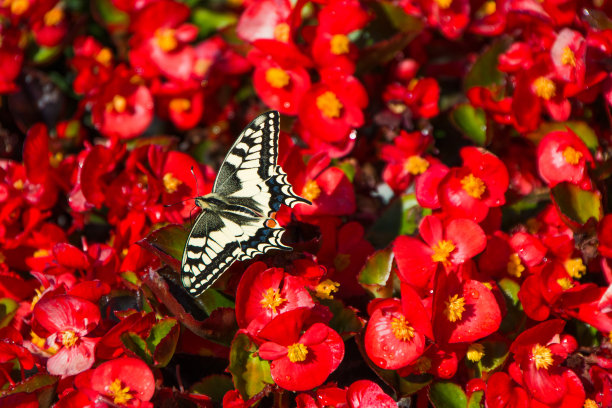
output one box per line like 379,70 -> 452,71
259,308 -> 344,391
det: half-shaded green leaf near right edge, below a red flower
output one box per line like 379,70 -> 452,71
551,183 -> 603,225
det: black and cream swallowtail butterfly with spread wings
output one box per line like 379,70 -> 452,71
181,111 -> 310,297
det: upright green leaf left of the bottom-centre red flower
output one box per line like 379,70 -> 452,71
228,334 -> 274,398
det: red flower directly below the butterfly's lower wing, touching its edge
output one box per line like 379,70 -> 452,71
236,262 -> 314,335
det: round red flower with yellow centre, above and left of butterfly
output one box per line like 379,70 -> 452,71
91,66 -> 153,139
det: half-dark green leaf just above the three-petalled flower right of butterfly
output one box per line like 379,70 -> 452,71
367,194 -> 431,249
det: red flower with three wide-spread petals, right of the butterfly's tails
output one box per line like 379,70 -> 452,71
393,216 -> 486,289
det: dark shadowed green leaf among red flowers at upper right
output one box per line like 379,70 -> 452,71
463,37 -> 511,90
